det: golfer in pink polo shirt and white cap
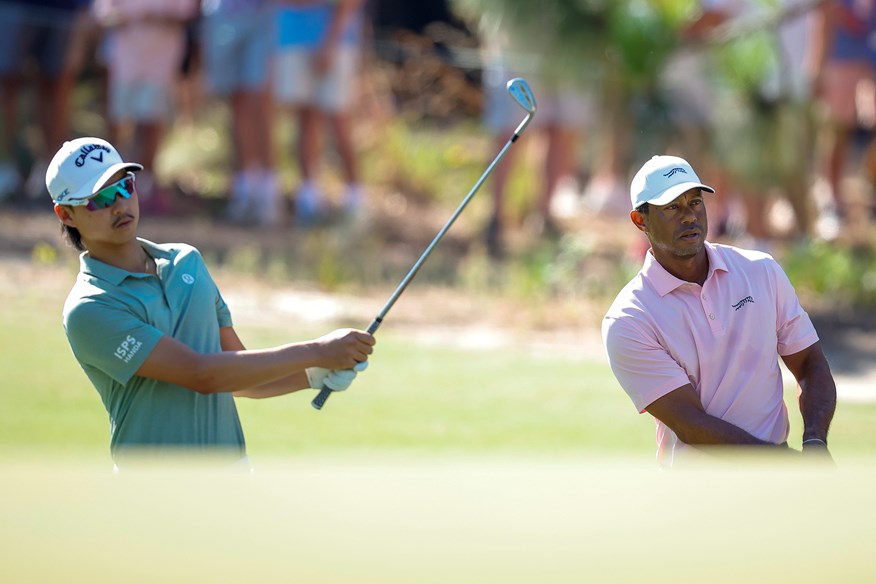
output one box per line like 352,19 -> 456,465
602,156 -> 836,466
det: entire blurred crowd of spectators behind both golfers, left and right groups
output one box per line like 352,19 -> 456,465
0,0 -> 876,256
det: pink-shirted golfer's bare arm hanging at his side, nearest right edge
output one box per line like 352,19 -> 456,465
782,343 -> 836,446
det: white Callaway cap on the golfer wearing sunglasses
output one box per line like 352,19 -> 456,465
46,138 -> 143,205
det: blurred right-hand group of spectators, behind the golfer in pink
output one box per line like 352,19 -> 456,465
473,0 -> 876,253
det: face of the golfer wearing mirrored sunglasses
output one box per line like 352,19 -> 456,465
56,170 -> 140,248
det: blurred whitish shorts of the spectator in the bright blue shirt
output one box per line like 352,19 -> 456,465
274,46 -> 359,112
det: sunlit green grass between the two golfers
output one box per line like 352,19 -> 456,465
233,324 -> 653,454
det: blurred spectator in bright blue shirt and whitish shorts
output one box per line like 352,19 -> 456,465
274,0 -> 364,225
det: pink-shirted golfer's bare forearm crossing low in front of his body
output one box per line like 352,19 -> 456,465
645,384 -> 774,446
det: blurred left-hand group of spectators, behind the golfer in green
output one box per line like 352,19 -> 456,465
0,0 -> 364,226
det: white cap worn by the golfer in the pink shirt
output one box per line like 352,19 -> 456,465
630,155 -> 715,209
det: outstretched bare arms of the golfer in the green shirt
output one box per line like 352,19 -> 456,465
137,329 -> 374,397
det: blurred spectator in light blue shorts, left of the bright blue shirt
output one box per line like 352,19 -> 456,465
202,0 -> 283,225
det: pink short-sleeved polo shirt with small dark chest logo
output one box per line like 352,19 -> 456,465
602,242 -> 818,465
